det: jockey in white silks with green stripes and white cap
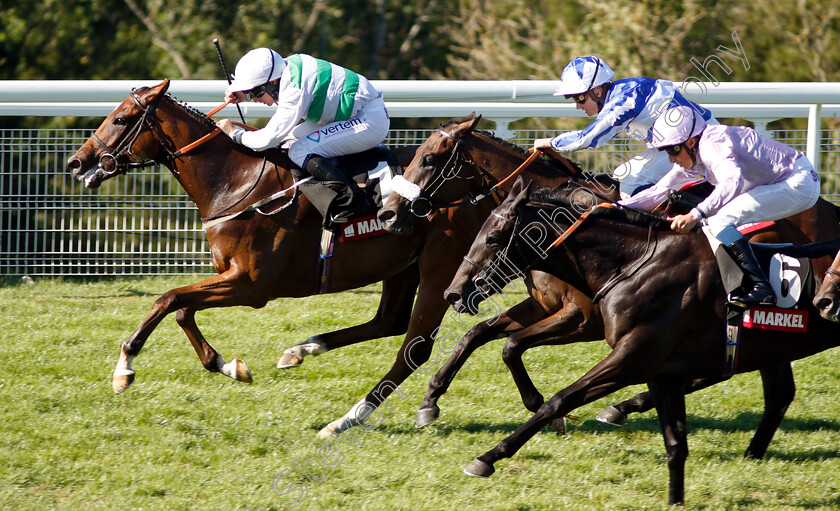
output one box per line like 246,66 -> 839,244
218,48 -> 391,222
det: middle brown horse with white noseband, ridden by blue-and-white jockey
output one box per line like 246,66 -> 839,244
386,114 -> 840,450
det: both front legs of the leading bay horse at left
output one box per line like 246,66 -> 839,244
113,271 -> 260,393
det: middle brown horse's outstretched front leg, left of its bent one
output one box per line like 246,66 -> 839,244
415,298 -> 545,428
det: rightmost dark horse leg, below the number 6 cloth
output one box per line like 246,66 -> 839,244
744,363 -> 796,459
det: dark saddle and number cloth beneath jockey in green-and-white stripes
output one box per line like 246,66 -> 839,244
291,145 -> 403,230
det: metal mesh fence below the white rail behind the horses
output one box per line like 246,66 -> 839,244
0,124 -> 840,276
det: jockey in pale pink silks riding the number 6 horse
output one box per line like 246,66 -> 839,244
618,107 -> 820,306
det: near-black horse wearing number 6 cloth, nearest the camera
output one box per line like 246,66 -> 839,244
450,182 -> 840,504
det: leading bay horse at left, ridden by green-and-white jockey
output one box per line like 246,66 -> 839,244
67,88 -> 568,436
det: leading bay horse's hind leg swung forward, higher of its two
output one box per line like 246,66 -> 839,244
277,264 -> 420,369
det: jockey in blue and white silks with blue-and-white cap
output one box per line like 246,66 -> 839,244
534,56 -> 717,197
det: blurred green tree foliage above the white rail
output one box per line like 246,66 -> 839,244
0,0 -> 840,130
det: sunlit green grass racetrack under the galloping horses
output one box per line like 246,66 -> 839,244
0,277 -> 840,511
